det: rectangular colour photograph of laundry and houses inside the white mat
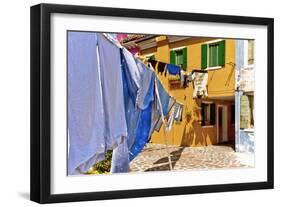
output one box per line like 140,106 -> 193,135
67,30 -> 256,176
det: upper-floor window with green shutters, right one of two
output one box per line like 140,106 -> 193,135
201,40 -> 225,69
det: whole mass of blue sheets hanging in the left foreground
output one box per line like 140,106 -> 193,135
68,32 -> 186,175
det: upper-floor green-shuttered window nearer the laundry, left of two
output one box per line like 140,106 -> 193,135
170,47 -> 187,70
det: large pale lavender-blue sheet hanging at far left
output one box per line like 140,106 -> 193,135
67,32 -> 127,175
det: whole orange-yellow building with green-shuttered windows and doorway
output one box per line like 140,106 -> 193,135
124,35 -> 235,146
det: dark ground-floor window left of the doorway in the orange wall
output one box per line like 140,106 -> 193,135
201,103 -> 216,126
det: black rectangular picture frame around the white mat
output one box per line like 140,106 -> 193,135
30,4 -> 274,203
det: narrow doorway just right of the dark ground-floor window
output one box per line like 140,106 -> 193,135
217,105 -> 228,143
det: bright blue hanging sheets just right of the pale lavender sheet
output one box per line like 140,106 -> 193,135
111,49 -> 155,170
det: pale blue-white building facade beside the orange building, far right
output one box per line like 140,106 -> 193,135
235,40 -> 255,153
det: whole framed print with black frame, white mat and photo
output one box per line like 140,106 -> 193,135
30,4 -> 274,203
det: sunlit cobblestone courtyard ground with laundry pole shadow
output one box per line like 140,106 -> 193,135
130,143 -> 253,172
